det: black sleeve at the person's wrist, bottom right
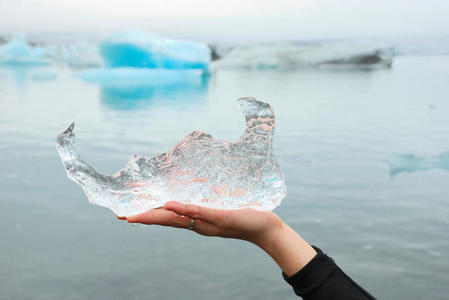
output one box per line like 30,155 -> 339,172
282,246 -> 375,300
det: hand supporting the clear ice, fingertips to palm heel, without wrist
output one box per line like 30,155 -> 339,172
120,201 -> 283,248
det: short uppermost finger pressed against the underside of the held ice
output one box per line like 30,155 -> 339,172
164,201 -> 221,223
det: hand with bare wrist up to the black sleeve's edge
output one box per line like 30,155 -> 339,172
119,201 -> 316,276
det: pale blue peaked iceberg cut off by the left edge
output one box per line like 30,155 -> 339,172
0,35 -> 51,66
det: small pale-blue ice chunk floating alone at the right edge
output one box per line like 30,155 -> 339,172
387,151 -> 449,176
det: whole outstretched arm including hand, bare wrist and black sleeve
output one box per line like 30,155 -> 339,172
133,201 -> 374,300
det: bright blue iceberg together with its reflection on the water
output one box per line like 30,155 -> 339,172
79,31 -> 211,110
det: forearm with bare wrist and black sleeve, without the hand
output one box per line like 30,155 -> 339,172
256,219 -> 374,300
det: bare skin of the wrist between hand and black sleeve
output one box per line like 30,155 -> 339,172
256,219 -> 317,276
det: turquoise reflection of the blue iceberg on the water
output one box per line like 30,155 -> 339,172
100,76 -> 209,110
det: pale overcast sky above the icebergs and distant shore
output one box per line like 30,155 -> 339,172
0,0 -> 449,41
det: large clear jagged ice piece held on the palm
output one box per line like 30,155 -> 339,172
56,98 -> 287,216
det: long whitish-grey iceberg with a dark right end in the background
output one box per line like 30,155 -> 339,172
214,42 -> 394,69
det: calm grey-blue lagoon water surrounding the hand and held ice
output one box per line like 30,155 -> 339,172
0,56 -> 449,299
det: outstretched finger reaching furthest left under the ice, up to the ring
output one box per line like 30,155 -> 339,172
127,209 -> 190,227
